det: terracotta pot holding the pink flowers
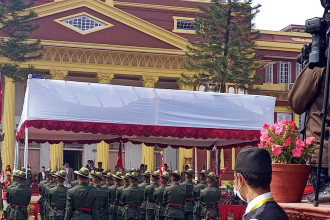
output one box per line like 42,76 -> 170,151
270,164 -> 312,203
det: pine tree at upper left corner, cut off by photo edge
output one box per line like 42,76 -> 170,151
0,0 -> 42,81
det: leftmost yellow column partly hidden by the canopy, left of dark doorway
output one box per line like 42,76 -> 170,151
49,70 -> 68,170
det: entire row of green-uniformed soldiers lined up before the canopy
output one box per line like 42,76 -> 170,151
7,167 -> 221,220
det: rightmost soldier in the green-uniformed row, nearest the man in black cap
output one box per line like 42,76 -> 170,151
200,172 -> 221,220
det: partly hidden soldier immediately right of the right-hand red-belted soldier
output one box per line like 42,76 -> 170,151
180,168 -> 194,220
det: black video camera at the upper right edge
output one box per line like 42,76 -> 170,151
297,0 -> 330,68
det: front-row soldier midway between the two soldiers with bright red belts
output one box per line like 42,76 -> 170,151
121,172 -> 143,220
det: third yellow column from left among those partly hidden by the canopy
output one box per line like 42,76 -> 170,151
142,76 -> 159,171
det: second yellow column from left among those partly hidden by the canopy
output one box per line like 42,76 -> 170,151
96,72 -> 115,170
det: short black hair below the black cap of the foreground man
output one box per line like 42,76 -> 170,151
240,172 -> 272,189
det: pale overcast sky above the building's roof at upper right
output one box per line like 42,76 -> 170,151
254,0 -> 323,31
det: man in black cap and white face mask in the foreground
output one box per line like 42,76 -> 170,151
234,147 -> 289,220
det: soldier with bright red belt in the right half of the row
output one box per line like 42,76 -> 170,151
164,170 -> 186,220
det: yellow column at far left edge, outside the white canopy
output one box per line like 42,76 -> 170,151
1,76 -> 15,169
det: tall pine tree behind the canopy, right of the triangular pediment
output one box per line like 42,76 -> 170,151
180,0 -> 260,93
